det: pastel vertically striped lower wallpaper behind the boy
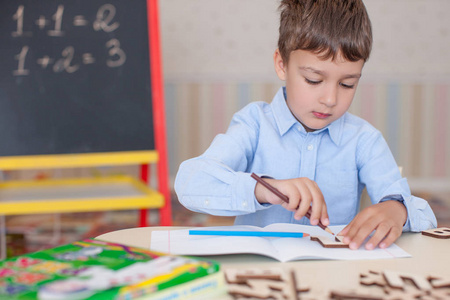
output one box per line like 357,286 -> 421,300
165,81 -> 450,178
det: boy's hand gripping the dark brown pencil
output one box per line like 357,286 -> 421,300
255,177 -> 330,226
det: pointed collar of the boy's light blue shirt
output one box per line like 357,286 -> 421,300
271,87 -> 347,145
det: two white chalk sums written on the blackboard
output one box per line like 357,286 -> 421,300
11,4 -> 127,76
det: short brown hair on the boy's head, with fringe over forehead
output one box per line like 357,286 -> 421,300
278,0 -> 372,63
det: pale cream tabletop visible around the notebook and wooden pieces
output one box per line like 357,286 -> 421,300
97,227 -> 450,299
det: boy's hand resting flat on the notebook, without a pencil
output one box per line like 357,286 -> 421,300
338,200 -> 408,250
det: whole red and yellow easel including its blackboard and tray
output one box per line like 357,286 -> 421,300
0,0 -> 171,257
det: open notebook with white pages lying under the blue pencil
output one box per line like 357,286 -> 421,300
151,223 -> 411,262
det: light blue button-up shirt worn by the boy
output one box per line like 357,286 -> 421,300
175,88 -> 437,231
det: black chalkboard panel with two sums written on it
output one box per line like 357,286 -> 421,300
0,0 -> 155,156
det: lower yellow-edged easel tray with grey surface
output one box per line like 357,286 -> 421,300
0,175 -> 164,215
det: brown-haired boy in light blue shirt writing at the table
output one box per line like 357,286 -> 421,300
175,0 -> 437,249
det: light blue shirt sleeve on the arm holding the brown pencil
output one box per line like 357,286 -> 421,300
175,108 -> 266,216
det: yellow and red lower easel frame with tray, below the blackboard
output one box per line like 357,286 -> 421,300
0,151 -> 171,259
